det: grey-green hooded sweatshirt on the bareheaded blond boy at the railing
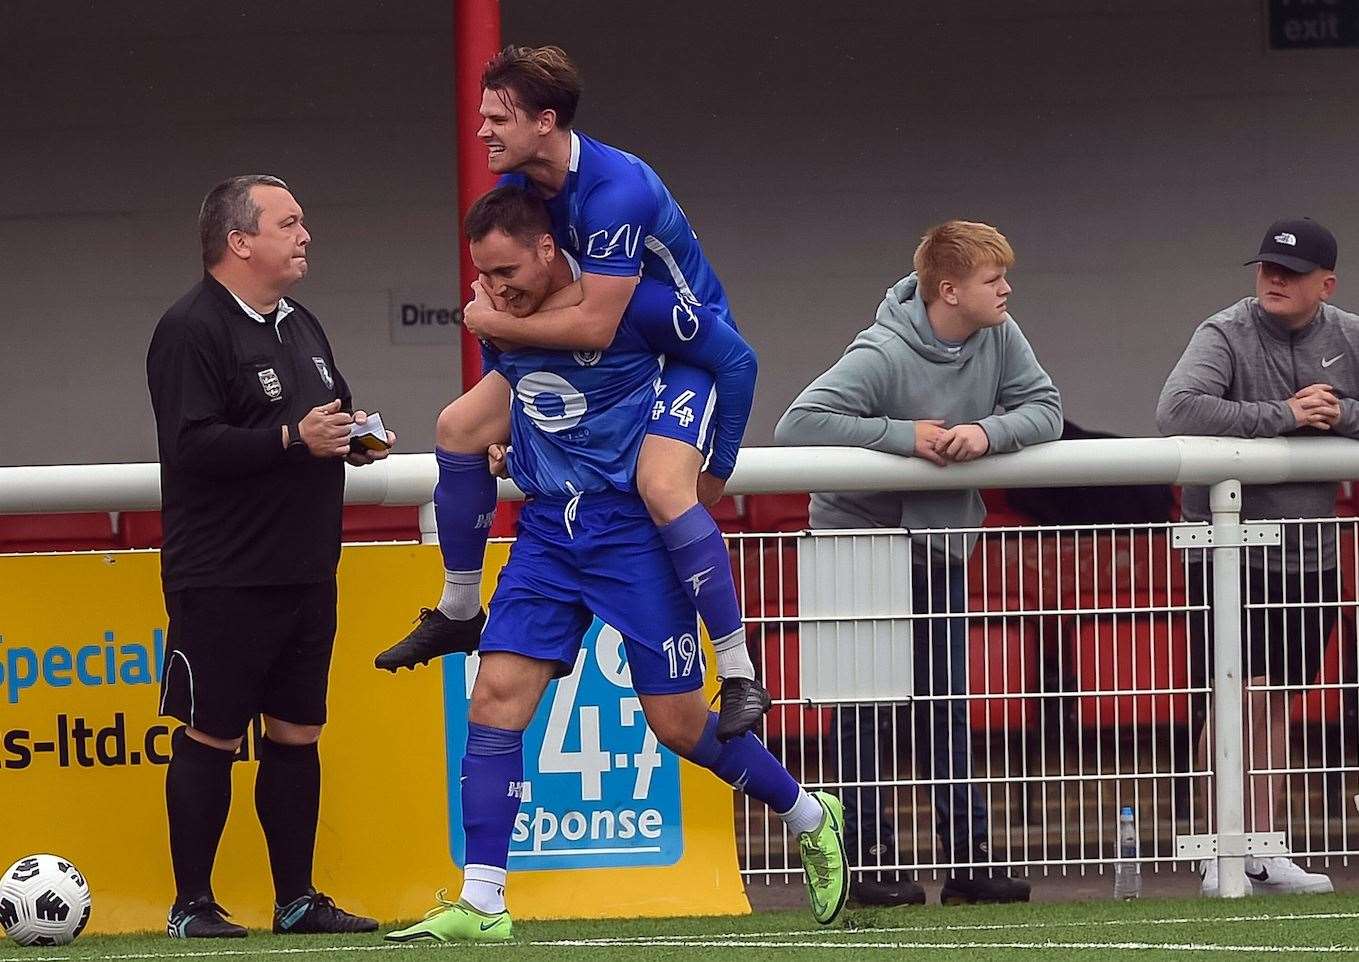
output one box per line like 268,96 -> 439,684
773,273 -> 1061,560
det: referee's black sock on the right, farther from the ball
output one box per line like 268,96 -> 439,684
255,735 -> 321,905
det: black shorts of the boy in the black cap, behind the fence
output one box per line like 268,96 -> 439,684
1188,561 -> 1340,688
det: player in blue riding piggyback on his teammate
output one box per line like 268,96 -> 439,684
376,46 -> 769,739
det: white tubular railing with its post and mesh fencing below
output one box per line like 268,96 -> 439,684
0,438 -> 1359,895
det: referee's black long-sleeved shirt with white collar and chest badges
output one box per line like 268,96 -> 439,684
147,274 -> 351,591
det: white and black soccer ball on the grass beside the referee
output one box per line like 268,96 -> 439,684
0,855 -> 90,946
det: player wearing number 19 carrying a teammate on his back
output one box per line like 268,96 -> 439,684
387,186 -> 848,942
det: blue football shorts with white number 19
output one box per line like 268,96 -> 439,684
480,492 -> 703,694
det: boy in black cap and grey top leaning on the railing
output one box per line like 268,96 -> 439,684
1157,219 -> 1359,895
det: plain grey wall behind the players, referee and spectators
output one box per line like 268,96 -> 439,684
0,0 -> 1359,463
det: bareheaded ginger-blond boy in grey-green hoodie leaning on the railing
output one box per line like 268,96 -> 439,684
775,220 -> 1061,905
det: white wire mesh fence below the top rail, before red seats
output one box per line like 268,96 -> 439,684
728,519 -> 1359,880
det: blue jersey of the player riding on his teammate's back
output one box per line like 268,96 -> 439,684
500,130 -> 733,323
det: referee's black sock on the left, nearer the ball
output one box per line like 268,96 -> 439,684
166,728 -> 235,905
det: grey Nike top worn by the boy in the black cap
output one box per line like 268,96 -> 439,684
1157,298 -> 1359,572
